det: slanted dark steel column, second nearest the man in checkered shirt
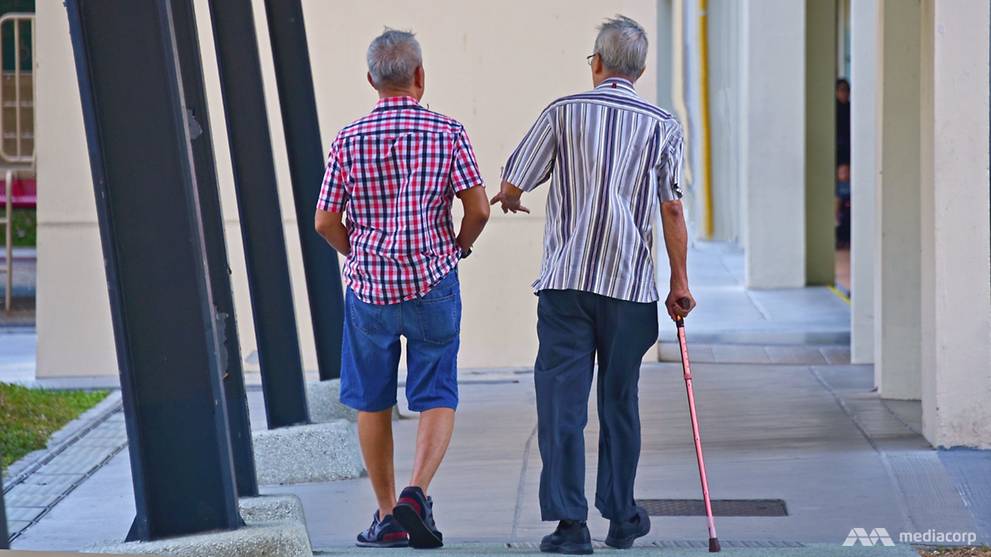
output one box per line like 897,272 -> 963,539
203,0 -> 309,428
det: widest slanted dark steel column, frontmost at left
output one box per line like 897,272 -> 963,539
66,0 -> 240,540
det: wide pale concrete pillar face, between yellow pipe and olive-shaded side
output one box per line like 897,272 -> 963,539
740,0 -> 805,288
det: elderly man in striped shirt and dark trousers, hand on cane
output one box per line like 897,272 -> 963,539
492,16 -> 695,554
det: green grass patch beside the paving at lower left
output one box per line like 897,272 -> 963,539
0,383 -> 107,469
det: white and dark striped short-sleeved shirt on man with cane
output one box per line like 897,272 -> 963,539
503,78 -> 683,302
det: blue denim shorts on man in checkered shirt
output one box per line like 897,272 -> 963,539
341,269 -> 461,412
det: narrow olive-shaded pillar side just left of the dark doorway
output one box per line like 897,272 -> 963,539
805,0 -> 836,286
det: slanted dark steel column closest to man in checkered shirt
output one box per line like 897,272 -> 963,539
265,0 -> 344,380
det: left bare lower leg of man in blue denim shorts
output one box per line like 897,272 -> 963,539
358,408 -> 396,518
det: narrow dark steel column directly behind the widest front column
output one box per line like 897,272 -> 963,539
172,0 -> 258,497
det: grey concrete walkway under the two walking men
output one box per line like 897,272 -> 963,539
3,244 -> 991,555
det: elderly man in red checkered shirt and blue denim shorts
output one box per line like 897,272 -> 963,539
316,29 -> 489,548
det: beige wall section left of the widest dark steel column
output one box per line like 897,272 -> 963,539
34,2 -> 118,377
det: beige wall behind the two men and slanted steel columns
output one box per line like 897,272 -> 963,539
36,0 -> 657,377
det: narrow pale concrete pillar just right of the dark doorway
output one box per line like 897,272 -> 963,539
850,0 -> 879,364
